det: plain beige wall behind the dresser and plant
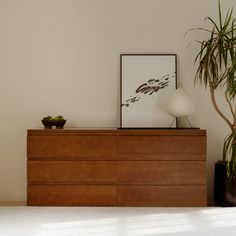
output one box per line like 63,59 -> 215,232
0,0 -> 236,201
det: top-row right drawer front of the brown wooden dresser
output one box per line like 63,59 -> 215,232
117,136 -> 206,160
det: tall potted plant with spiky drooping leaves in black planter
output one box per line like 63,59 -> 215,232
195,1 -> 236,206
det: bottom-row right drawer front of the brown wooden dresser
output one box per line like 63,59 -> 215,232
117,186 -> 207,207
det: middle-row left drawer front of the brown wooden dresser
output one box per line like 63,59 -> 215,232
28,160 -> 116,183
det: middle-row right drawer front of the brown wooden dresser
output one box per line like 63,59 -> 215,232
117,161 -> 206,185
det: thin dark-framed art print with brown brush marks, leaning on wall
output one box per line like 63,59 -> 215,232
120,54 -> 177,128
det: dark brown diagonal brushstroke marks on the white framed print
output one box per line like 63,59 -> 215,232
121,73 -> 175,108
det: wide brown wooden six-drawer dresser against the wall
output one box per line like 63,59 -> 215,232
27,129 -> 207,207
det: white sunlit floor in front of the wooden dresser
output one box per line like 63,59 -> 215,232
0,207 -> 236,236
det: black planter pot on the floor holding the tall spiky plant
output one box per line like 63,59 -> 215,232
214,163 -> 236,206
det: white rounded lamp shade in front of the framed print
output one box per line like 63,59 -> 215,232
167,88 -> 195,117
